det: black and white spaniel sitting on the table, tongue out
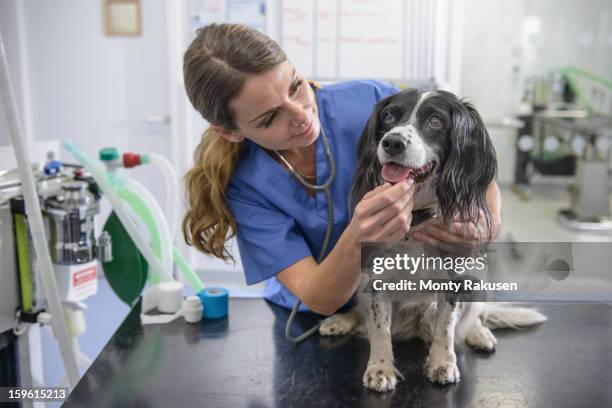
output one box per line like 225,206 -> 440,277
319,90 -> 546,391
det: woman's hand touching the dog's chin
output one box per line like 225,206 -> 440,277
349,179 -> 414,244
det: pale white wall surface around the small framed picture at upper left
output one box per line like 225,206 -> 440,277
24,0 -> 169,167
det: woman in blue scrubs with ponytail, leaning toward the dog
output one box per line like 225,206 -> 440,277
183,24 -> 500,315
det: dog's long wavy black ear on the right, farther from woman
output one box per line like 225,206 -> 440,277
436,101 -> 497,237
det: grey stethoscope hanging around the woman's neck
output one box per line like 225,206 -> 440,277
274,123 -> 336,343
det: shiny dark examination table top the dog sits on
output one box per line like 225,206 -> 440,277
64,299 -> 612,408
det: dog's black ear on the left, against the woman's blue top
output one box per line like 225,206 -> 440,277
349,96 -> 391,216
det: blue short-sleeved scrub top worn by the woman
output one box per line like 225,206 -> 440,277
226,80 -> 398,311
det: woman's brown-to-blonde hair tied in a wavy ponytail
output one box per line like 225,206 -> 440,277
183,24 -> 287,260
